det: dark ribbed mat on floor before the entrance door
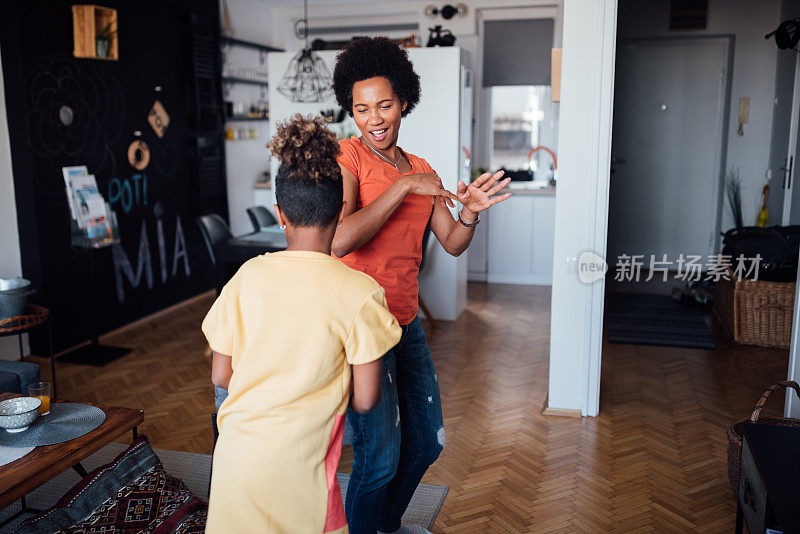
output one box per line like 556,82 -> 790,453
606,292 -> 717,349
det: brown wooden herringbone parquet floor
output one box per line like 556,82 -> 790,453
26,284 -> 788,532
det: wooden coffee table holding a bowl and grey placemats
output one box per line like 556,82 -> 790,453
0,393 -> 144,521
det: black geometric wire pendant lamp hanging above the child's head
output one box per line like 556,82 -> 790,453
278,0 -> 333,102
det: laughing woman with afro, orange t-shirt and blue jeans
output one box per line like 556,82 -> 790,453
331,37 -> 510,534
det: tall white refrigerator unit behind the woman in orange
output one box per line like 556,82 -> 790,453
266,47 -> 472,321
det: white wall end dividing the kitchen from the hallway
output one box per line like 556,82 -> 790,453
548,0 -> 617,415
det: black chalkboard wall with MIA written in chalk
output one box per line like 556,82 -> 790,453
0,0 -> 227,352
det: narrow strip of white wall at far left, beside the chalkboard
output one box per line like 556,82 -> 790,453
0,48 -> 28,360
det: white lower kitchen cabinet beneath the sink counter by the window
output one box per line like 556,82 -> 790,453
468,190 -> 556,285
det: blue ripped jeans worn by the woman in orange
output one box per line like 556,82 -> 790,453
345,317 -> 445,534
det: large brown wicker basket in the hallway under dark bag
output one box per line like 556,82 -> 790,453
714,268 -> 795,349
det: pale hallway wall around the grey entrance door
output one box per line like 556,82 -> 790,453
618,0 -> 780,232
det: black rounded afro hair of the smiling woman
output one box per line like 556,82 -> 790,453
333,37 -> 420,117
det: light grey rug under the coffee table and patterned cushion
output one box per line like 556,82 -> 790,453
0,443 -> 449,532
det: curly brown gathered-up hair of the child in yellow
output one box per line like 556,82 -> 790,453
267,114 -> 343,226
